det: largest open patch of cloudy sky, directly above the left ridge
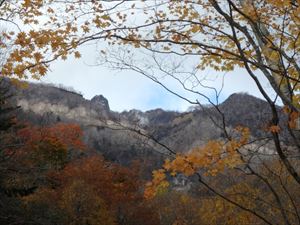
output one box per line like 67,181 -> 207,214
42,53 -> 183,111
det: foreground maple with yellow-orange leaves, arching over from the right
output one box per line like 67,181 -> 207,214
0,0 -> 300,225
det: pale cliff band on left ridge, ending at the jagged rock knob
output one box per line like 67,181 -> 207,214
17,83 -> 110,125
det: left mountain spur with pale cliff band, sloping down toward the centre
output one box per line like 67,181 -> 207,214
16,83 -> 166,166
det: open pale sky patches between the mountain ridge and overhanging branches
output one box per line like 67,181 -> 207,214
41,43 -> 278,111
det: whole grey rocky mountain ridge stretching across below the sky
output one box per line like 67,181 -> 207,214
11,81 -> 286,167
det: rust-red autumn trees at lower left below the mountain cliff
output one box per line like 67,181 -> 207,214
0,123 -> 158,225
